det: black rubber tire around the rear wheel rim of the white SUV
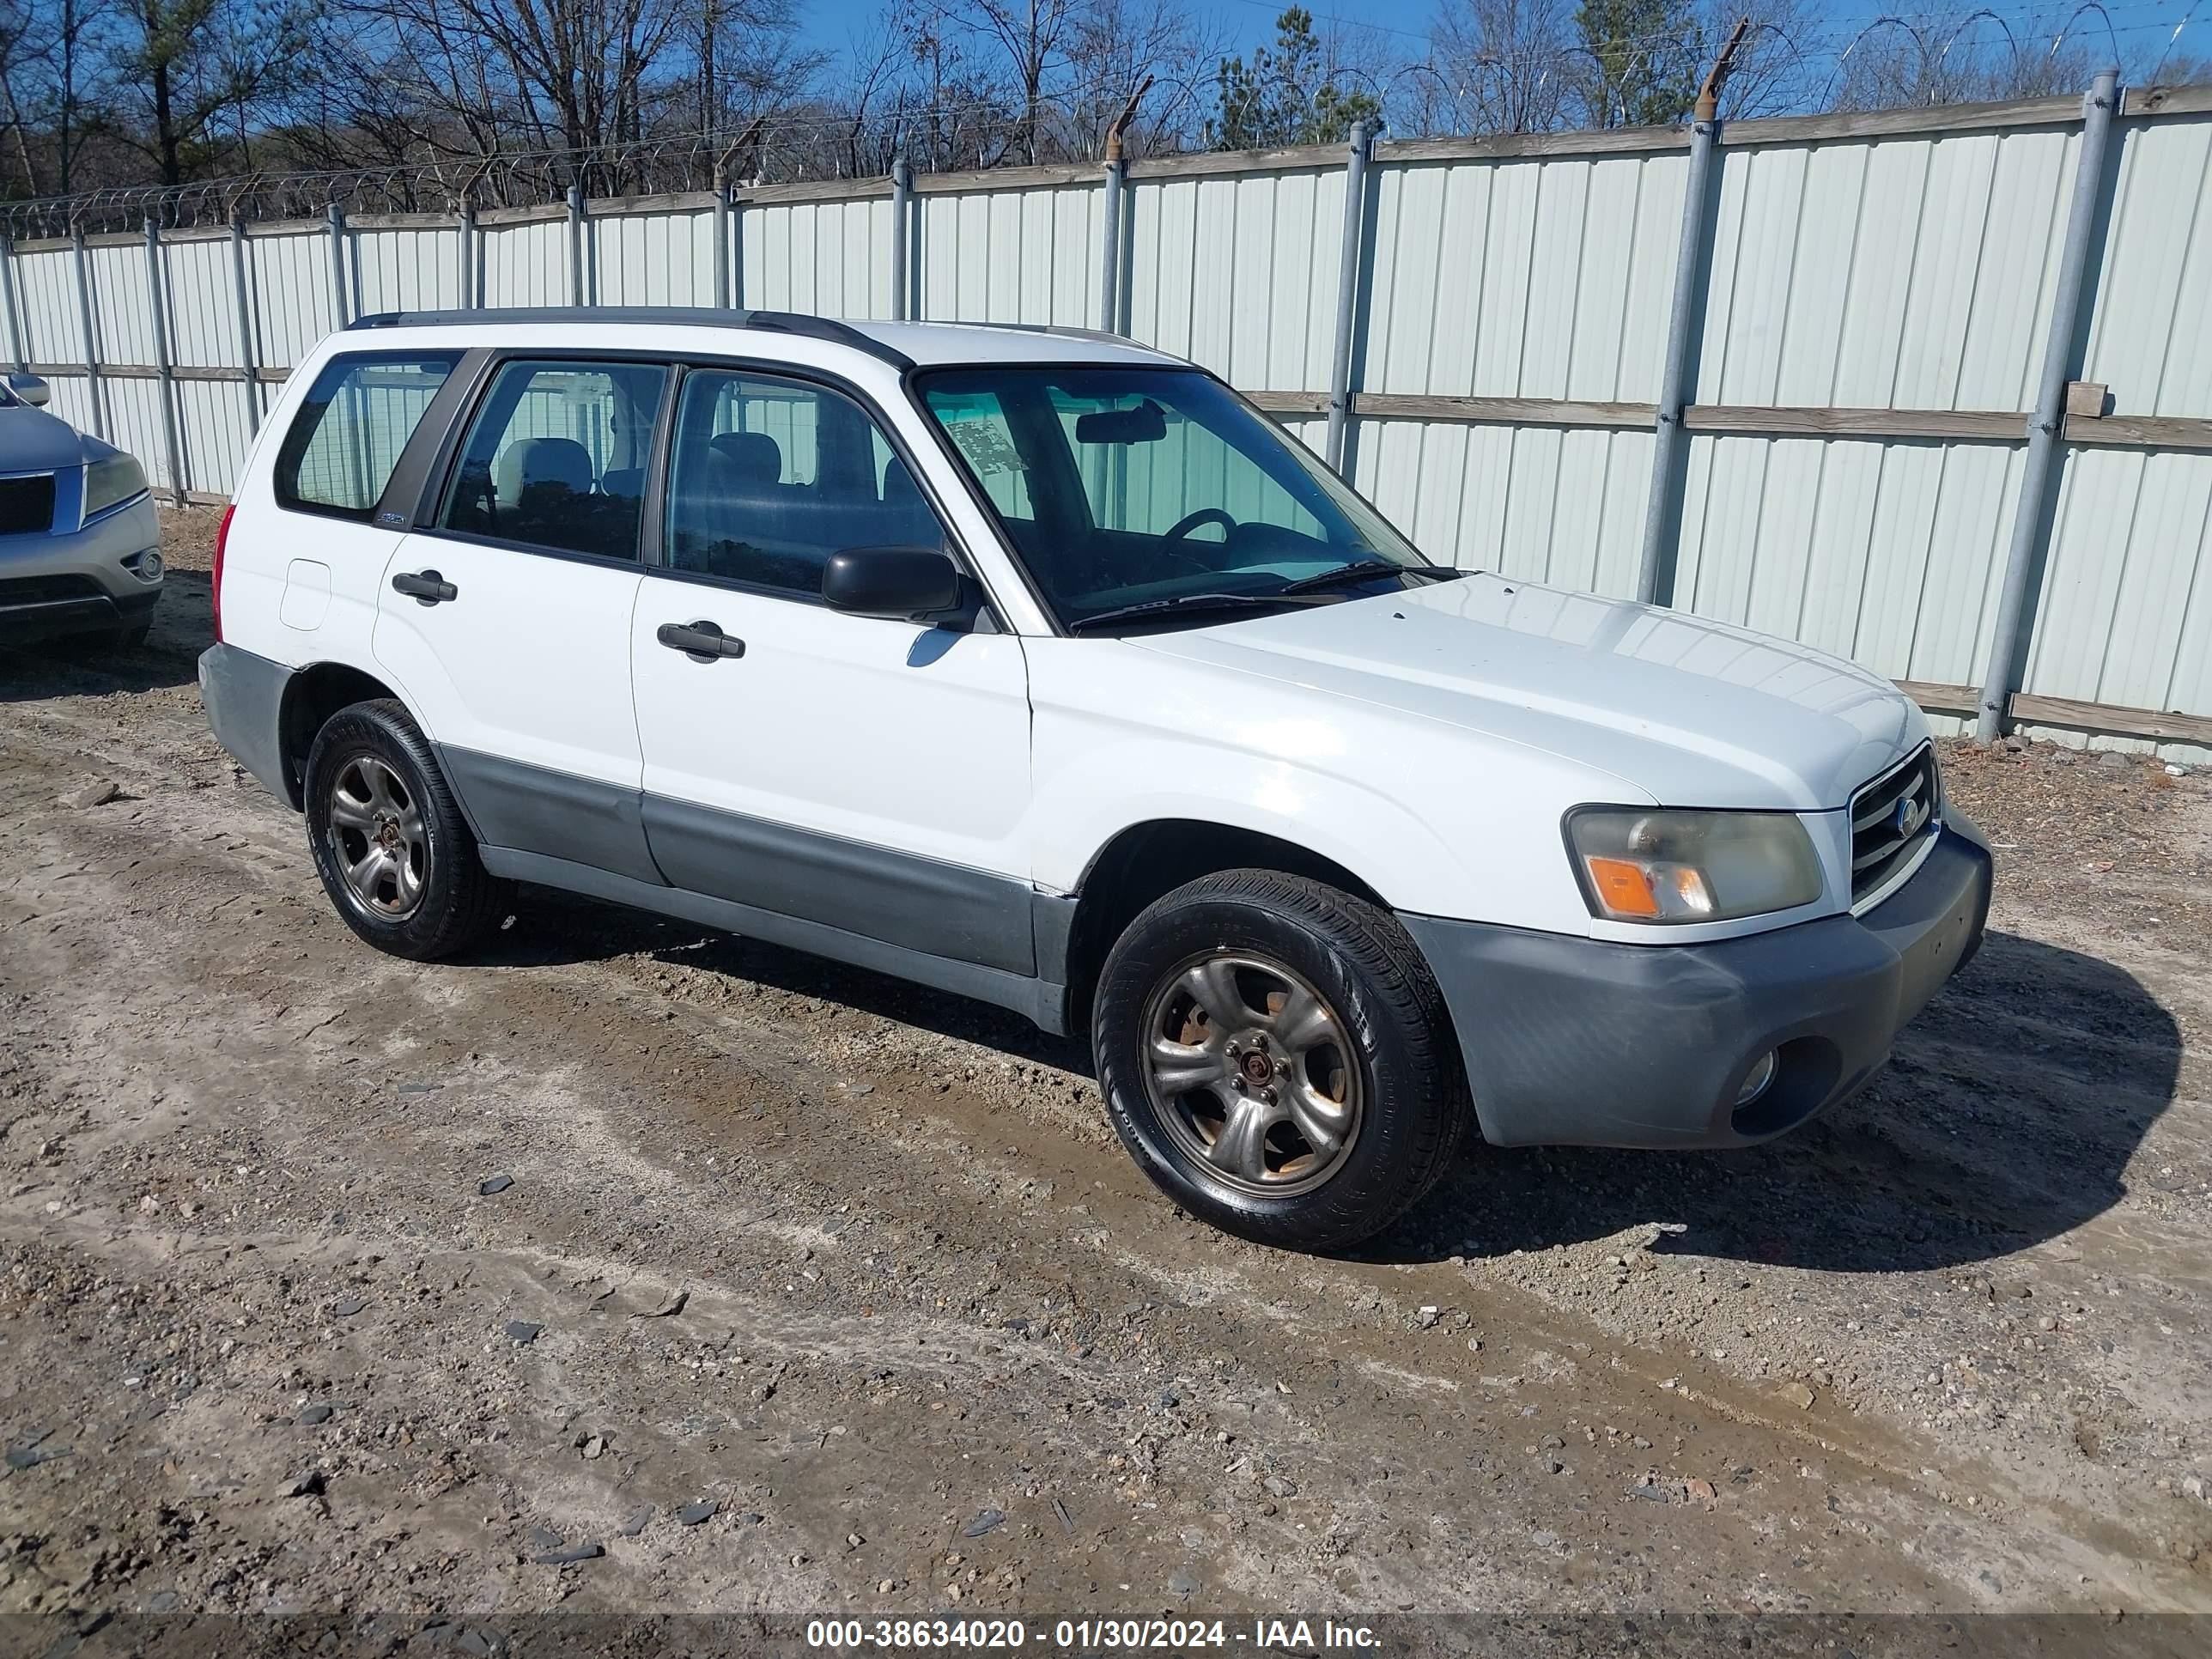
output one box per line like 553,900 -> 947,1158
305,696 -> 507,963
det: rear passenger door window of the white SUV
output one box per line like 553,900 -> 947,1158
441,362 -> 668,560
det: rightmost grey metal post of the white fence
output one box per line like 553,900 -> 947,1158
1973,69 -> 2119,744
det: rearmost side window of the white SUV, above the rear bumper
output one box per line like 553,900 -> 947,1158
276,352 -> 460,520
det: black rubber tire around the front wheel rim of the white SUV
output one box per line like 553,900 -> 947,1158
1091,869 -> 1474,1249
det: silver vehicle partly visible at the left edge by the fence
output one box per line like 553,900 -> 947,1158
0,374 -> 161,646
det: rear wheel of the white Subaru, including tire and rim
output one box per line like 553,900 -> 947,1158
305,699 -> 504,963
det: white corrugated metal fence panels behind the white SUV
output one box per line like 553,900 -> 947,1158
13,88 -> 2212,759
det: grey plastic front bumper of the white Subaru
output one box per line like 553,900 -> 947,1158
1401,814 -> 1990,1148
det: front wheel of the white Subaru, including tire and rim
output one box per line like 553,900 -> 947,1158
1091,869 -> 1471,1249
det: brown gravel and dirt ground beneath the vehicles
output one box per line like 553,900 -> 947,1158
0,511 -> 2212,1641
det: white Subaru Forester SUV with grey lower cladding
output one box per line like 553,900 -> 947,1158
199,310 -> 1990,1248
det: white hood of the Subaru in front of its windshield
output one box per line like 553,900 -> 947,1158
1128,573 -> 1929,811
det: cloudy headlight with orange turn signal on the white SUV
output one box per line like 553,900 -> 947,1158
1566,807 -> 1820,922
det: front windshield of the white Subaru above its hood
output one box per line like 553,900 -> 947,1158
918,365 -> 1431,629
